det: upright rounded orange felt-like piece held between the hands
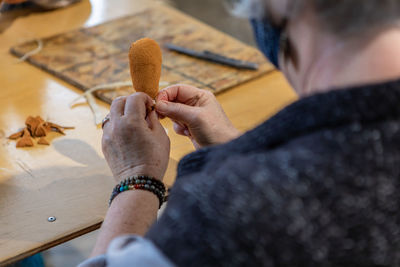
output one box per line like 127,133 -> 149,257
129,38 -> 162,99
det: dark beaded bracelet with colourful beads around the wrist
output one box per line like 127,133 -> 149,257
108,175 -> 165,208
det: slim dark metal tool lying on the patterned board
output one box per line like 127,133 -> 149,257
164,44 -> 258,70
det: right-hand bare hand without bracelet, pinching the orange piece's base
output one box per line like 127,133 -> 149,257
156,85 -> 240,148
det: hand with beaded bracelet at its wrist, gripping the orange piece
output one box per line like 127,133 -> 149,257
102,93 -> 170,182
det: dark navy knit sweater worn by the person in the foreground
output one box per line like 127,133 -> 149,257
147,81 -> 400,266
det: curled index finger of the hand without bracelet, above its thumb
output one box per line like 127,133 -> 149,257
156,84 -> 204,104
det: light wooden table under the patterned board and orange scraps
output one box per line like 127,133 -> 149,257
0,0 -> 296,265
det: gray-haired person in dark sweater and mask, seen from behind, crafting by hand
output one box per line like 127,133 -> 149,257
81,0 -> 400,266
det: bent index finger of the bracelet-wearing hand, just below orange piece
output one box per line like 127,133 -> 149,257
124,93 -> 153,120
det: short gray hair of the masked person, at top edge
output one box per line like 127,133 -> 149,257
230,0 -> 400,35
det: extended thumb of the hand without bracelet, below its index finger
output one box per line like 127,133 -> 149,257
156,100 -> 196,124
